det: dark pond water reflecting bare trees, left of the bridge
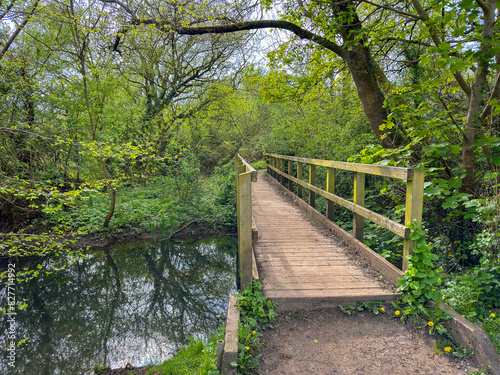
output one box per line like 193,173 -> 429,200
0,236 -> 236,375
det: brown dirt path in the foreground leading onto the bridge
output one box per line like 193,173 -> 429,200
259,309 -> 476,375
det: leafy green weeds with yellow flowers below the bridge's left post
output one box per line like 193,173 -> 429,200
233,281 -> 277,374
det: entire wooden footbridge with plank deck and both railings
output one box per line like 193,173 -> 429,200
235,154 -> 424,310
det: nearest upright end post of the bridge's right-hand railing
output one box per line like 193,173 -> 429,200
403,170 -> 425,272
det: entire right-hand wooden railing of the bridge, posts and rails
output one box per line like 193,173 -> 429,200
264,153 -> 424,271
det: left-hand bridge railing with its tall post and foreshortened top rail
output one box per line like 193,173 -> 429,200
234,154 -> 257,290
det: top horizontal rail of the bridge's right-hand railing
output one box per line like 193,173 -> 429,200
264,152 -> 413,180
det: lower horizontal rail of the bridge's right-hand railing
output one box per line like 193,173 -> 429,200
268,167 -> 410,238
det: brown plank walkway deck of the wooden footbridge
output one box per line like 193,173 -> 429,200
252,171 -> 397,310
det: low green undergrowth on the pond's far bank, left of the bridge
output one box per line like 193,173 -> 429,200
33,165 -> 236,241
